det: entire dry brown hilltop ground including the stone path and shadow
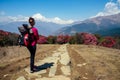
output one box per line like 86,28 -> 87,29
0,44 -> 120,80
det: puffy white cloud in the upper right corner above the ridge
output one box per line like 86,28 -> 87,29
93,0 -> 120,17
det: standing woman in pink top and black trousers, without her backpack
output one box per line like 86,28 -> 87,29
27,17 -> 39,73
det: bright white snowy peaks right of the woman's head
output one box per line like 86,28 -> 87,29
32,13 -> 74,24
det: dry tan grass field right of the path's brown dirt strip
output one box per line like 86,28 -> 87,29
70,45 -> 120,80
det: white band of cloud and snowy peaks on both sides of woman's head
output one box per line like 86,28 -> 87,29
0,13 -> 74,24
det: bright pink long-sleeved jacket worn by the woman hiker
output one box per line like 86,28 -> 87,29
31,27 -> 39,46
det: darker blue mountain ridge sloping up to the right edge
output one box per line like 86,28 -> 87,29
55,13 -> 120,36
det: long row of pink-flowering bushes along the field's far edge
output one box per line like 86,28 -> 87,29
0,30 -> 120,49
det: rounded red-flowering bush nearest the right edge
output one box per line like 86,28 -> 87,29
100,37 -> 116,48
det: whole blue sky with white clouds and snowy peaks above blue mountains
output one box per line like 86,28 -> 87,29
0,0 -> 120,24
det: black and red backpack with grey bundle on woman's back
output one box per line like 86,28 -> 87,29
18,24 -> 30,46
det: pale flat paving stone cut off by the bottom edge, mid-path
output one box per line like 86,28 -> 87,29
35,75 -> 71,80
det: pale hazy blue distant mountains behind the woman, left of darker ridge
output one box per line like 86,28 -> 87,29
0,21 -> 66,36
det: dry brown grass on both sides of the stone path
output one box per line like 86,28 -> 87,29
0,45 -> 120,80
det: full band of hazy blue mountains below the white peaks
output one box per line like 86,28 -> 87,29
0,13 -> 120,36
